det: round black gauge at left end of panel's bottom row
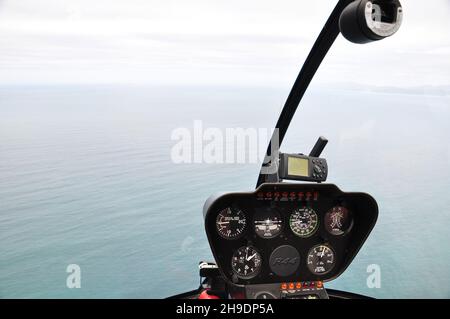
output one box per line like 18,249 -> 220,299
231,246 -> 262,279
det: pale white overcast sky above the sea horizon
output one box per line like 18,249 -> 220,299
0,0 -> 450,86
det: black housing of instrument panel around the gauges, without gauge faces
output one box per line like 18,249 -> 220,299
203,183 -> 378,285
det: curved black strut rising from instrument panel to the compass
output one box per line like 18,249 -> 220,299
256,0 -> 354,187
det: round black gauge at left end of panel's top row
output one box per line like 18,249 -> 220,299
216,207 -> 246,239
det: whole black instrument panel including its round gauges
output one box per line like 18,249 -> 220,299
204,183 -> 378,285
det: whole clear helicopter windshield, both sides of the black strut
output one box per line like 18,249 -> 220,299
0,0 -> 450,298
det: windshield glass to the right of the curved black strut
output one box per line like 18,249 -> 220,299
282,1 -> 450,298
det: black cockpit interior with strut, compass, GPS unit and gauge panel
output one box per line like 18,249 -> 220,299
169,0 -> 403,299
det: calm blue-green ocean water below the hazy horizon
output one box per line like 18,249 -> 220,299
0,86 -> 450,298
